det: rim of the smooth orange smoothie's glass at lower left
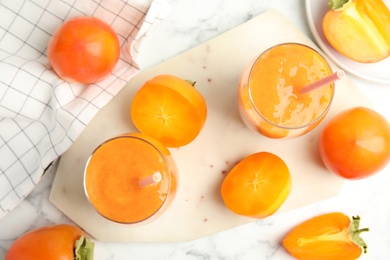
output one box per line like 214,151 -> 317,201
83,134 -> 172,225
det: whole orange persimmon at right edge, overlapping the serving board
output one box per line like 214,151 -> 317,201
319,107 -> 390,179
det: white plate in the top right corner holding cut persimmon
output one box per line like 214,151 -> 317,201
306,0 -> 390,84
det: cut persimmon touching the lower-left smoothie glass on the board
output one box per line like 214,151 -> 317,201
130,75 -> 207,147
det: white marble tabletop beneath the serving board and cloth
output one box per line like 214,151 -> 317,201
0,0 -> 390,260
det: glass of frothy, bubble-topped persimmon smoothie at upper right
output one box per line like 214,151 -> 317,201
238,43 -> 334,138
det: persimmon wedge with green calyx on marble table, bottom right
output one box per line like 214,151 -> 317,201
283,212 -> 369,260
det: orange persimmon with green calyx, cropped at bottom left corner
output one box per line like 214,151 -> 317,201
5,224 -> 94,260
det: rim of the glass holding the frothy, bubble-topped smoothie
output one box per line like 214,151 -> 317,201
246,42 -> 335,130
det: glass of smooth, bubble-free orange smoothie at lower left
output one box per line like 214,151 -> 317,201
84,133 -> 177,224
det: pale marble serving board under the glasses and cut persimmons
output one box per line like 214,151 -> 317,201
50,10 -> 370,242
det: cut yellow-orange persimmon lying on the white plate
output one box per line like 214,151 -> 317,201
322,0 -> 390,63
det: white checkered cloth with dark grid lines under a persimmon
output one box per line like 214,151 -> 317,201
0,0 -> 167,218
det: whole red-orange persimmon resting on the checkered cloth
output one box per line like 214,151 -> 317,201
47,16 -> 120,84
